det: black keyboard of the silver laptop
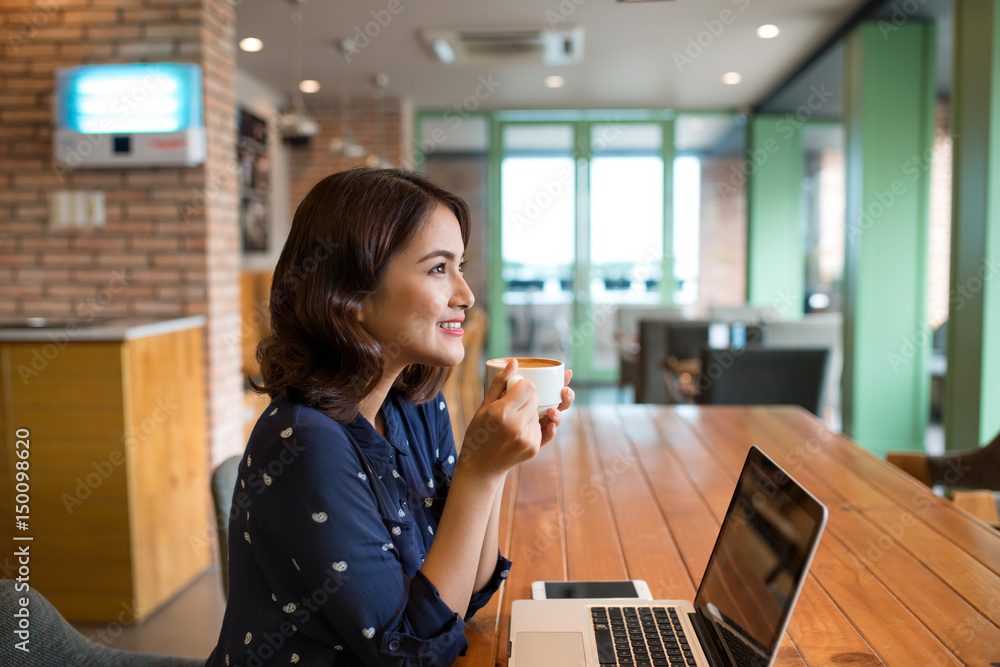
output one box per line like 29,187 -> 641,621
590,607 -> 696,667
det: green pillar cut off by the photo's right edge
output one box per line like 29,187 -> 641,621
944,0 -> 1000,449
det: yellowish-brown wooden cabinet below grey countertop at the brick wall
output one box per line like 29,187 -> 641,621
0,325 -> 215,623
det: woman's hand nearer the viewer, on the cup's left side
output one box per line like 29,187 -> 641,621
456,359 -> 542,476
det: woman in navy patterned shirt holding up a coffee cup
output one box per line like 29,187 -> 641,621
208,168 -> 573,667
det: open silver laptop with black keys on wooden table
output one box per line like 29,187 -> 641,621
507,446 -> 827,667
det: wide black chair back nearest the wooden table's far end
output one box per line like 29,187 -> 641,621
695,347 -> 830,415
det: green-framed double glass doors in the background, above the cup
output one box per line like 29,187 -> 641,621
493,120 -> 674,380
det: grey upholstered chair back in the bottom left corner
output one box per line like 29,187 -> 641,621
0,579 -> 205,667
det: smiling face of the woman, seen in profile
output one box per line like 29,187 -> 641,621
361,204 -> 475,375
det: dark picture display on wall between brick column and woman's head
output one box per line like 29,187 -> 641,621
236,109 -> 271,252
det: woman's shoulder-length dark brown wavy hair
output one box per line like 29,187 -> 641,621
251,167 -> 469,422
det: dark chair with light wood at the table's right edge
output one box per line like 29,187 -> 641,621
885,433 -> 1000,529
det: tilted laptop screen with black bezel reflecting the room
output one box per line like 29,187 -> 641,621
694,447 -> 826,666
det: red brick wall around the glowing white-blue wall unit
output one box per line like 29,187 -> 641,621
0,0 -> 242,458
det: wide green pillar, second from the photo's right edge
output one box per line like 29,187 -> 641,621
842,21 -> 935,456
